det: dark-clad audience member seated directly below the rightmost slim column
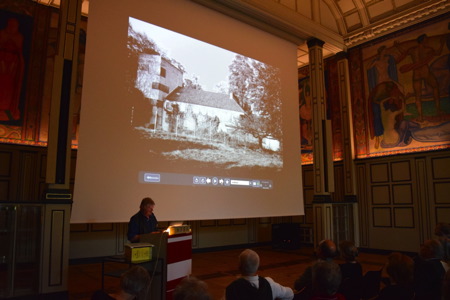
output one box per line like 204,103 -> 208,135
339,241 -> 363,300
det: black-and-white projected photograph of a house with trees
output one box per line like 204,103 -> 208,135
126,17 -> 283,171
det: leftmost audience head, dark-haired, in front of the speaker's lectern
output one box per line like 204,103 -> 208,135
120,266 -> 150,299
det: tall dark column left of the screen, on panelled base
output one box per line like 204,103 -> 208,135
39,0 -> 81,294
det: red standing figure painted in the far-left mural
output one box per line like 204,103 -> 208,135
0,18 -> 24,121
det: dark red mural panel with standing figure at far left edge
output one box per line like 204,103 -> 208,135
0,10 -> 33,126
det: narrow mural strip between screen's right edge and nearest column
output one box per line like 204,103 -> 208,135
298,68 -> 313,164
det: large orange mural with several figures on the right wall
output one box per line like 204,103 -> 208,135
362,20 -> 450,156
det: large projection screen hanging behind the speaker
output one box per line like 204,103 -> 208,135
71,0 -> 304,223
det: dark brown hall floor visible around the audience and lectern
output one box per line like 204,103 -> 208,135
68,246 -> 387,300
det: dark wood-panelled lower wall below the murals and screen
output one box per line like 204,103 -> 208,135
0,144 -> 450,258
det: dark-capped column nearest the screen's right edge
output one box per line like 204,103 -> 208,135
307,39 -> 334,245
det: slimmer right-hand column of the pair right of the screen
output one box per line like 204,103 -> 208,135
336,52 -> 359,246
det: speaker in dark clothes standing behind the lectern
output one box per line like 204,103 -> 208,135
128,197 -> 158,243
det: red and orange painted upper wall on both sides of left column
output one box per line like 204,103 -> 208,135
0,0 -> 87,148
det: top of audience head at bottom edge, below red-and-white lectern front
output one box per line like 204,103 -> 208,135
173,276 -> 212,300
